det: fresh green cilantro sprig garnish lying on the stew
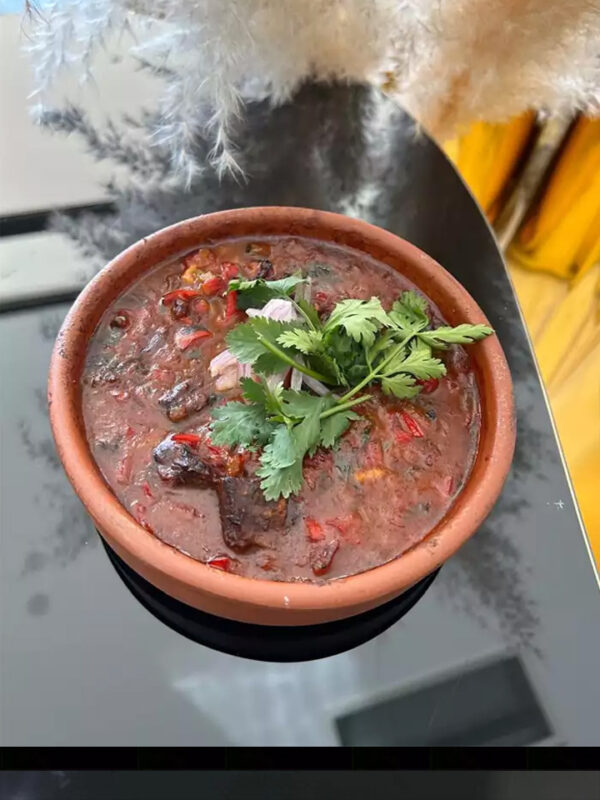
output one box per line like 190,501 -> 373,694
211,274 -> 493,500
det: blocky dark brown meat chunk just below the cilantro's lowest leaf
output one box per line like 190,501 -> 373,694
216,478 -> 287,550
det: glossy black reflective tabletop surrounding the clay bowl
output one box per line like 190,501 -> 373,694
0,87 -> 600,745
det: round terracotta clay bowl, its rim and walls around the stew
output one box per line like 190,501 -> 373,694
48,207 -> 515,626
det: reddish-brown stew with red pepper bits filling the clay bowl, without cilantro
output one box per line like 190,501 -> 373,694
82,238 -> 480,582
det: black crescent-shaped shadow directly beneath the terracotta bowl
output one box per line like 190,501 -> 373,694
102,540 -> 439,661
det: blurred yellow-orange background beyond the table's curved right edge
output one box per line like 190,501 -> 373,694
445,113 -> 600,567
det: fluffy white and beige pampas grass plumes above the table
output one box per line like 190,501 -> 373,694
24,0 -> 600,183
